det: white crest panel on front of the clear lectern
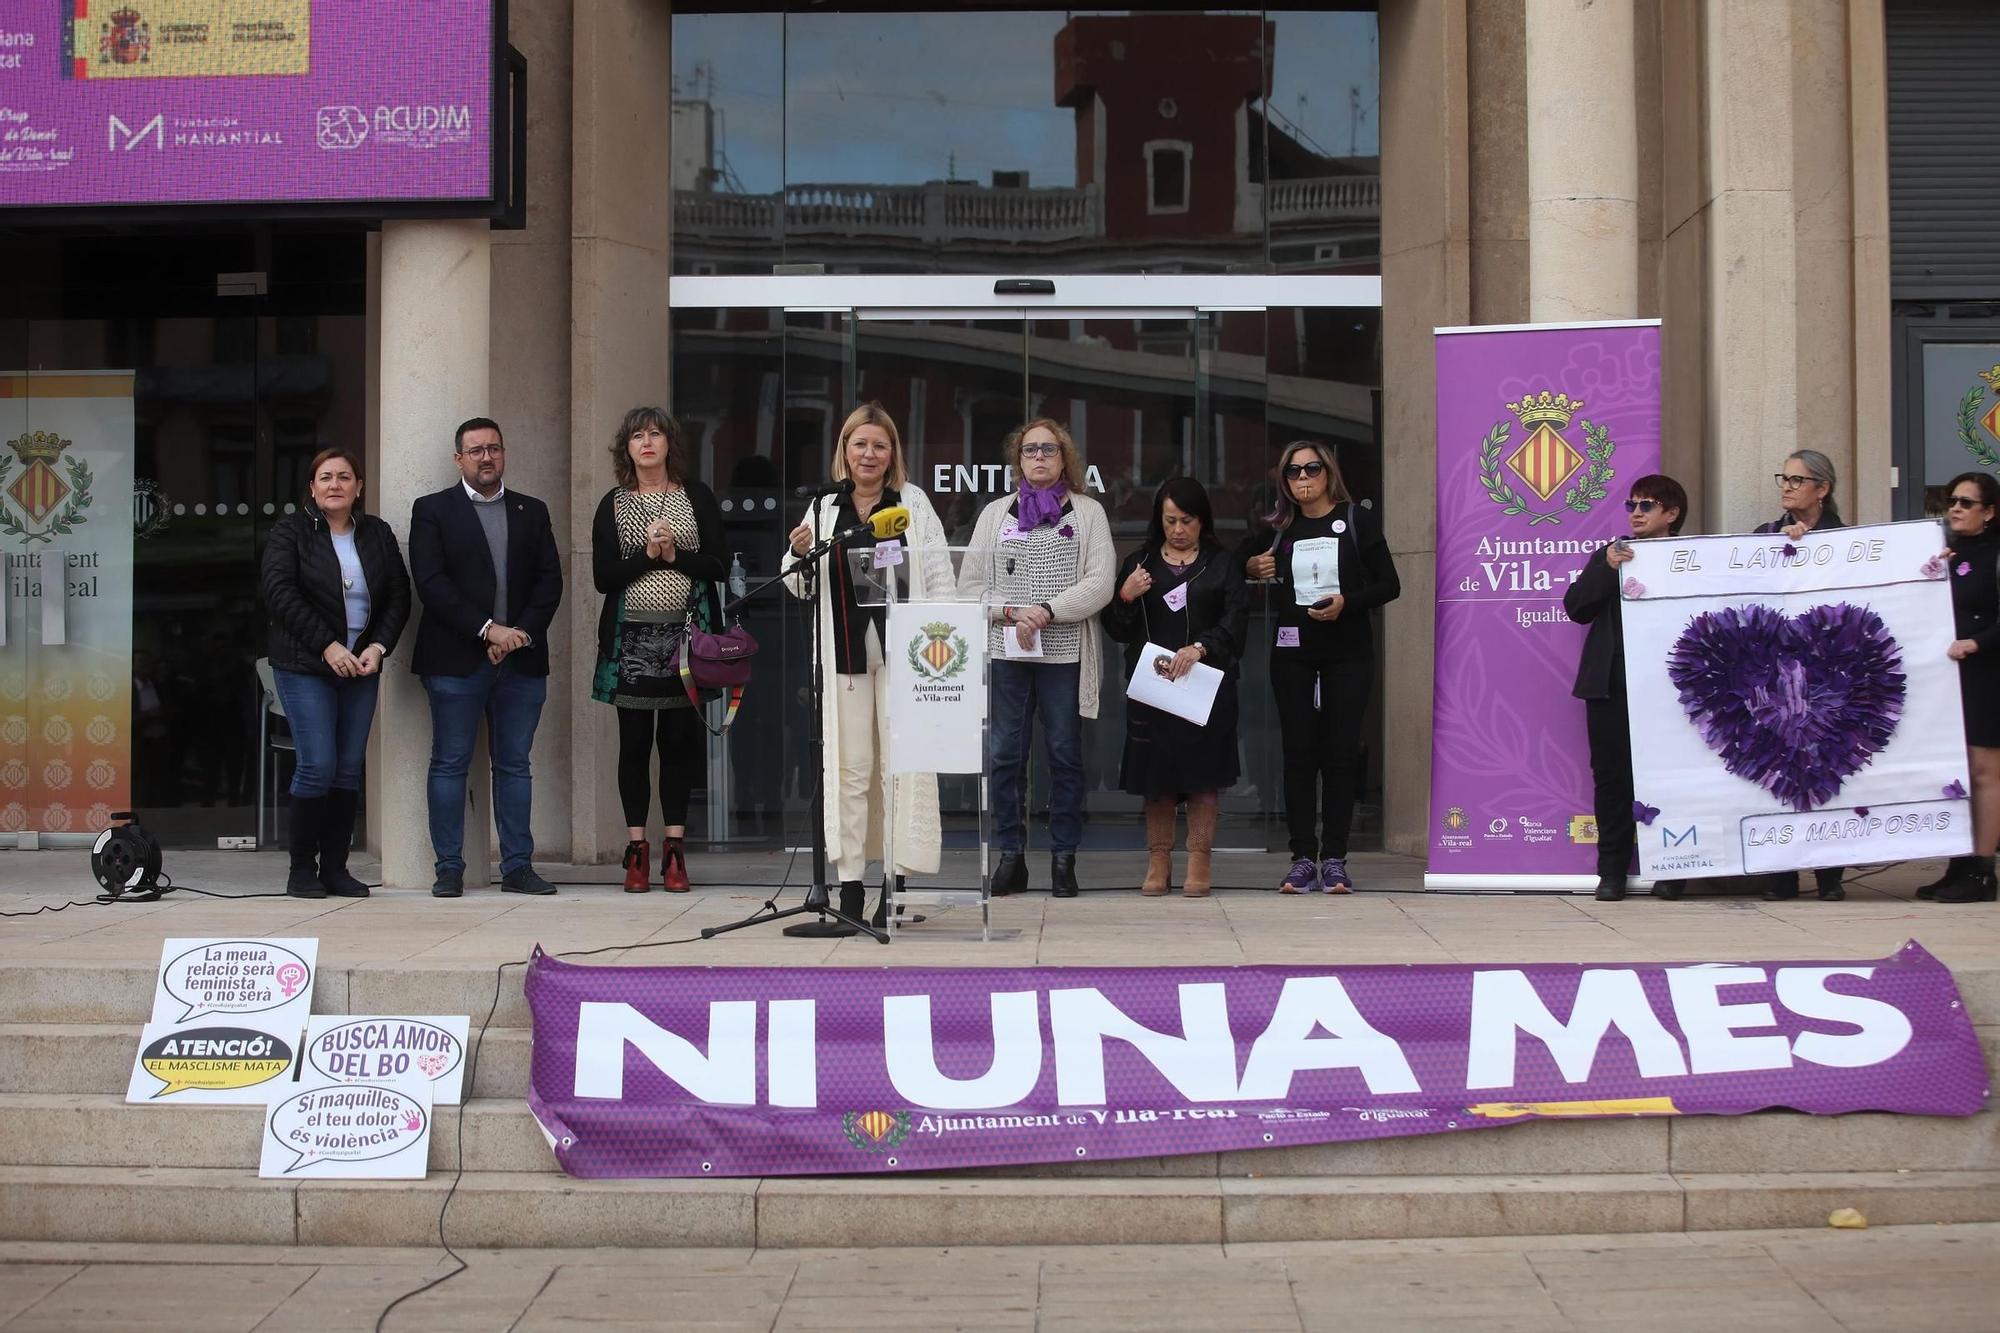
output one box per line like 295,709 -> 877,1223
884,602 -> 986,773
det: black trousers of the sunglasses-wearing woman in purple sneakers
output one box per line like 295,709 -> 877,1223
1270,648 -> 1374,859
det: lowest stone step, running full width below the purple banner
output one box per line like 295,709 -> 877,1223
0,1167 -> 2000,1249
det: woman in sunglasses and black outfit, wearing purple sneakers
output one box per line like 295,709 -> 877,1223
1246,440 -> 1402,893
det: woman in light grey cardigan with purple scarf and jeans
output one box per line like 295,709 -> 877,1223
958,416 -> 1118,899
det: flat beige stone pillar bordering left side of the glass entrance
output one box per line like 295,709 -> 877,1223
568,0 -> 674,865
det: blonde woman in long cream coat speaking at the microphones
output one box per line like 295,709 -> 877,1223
784,402 -> 954,925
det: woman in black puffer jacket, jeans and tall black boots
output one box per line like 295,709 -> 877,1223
262,446 -> 410,899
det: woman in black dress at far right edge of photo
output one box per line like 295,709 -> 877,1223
1918,472 -> 2000,903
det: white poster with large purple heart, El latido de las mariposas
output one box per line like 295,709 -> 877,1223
1622,522 -> 1972,879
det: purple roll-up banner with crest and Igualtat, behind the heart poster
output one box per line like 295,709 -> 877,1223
1424,320 -> 1660,891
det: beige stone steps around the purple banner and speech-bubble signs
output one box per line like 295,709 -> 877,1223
0,963 -> 2000,1247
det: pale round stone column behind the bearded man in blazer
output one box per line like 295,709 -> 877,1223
368,222 -> 492,889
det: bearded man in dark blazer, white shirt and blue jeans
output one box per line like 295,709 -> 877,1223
410,416 -> 562,899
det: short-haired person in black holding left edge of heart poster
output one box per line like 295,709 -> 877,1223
1562,474 -> 1688,903
